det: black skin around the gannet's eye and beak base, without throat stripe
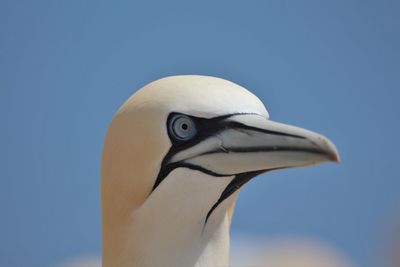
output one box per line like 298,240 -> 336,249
152,112 -> 254,192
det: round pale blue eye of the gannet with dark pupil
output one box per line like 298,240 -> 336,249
169,114 -> 197,141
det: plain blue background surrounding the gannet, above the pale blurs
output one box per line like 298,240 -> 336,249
0,0 -> 400,267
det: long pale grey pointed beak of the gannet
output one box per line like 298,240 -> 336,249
170,114 -> 340,175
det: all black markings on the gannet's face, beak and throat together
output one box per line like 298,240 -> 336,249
152,112 -> 310,225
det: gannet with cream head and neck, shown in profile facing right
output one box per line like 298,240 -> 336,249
101,75 -> 339,267
